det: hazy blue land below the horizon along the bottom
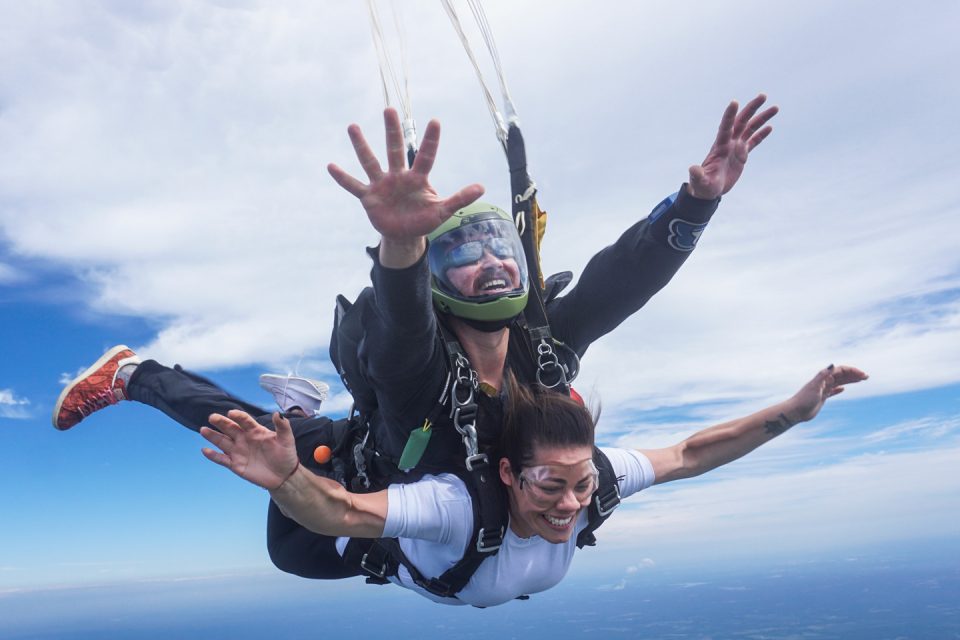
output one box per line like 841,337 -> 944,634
0,552 -> 960,640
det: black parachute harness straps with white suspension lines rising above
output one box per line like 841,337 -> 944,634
345,0 -> 600,599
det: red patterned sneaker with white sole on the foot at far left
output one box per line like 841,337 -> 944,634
53,344 -> 140,431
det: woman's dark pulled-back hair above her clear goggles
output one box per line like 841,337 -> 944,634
500,373 -> 599,475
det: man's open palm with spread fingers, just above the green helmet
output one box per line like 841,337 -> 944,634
327,109 -> 483,241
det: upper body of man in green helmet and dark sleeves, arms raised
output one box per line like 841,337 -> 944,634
328,95 -> 777,469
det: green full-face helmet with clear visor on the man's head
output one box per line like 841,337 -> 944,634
427,202 -> 530,321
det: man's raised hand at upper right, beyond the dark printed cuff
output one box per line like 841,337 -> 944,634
689,93 -> 779,200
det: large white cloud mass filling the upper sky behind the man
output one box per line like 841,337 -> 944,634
0,1 -> 960,419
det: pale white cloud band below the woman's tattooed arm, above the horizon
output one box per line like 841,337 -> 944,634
600,444 -> 960,557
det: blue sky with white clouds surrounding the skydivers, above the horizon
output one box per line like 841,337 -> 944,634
0,0 -> 960,591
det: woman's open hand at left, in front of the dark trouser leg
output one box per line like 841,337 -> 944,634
200,410 -> 299,491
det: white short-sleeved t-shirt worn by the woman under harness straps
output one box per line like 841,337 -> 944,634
338,449 -> 654,607
